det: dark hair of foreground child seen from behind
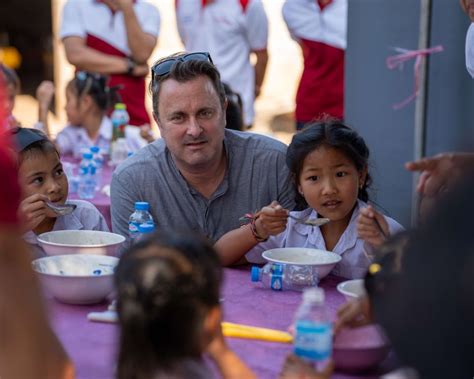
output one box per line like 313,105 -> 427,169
115,233 -> 222,379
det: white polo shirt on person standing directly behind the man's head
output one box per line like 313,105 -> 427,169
176,0 -> 268,125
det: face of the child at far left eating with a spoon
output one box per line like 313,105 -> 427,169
19,151 -> 68,204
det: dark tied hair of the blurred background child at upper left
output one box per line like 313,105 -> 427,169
67,71 -> 120,111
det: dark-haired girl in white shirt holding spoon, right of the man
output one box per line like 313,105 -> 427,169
215,120 -> 403,278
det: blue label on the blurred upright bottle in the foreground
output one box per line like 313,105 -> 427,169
294,321 -> 332,361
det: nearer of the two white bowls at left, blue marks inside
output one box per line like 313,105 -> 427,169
32,255 -> 119,304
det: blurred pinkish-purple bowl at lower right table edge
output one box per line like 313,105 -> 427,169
333,324 -> 390,372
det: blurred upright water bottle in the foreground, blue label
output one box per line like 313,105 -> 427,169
293,287 -> 332,366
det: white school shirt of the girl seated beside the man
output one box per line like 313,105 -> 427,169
245,200 -> 403,279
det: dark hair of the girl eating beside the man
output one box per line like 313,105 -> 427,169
286,119 -> 372,208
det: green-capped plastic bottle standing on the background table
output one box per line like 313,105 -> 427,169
110,103 -> 130,165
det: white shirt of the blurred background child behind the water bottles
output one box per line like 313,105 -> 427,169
56,116 -> 147,158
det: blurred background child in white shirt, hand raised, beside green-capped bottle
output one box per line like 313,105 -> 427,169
56,71 -> 147,158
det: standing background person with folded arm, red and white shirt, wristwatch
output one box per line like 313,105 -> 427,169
60,0 -> 160,126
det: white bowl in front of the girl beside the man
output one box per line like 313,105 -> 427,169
262,247 -> 341,279
